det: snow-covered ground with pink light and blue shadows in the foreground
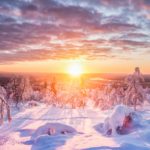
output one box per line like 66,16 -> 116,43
0,104 -> 150,150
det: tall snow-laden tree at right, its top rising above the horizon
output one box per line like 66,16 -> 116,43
125,67 -> 145,110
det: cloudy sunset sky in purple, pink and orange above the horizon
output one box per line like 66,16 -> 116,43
0,0 -> 150,73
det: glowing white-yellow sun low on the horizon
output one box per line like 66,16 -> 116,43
68,63 -> 83,77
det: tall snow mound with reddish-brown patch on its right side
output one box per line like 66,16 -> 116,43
95,105 -> 142,136
